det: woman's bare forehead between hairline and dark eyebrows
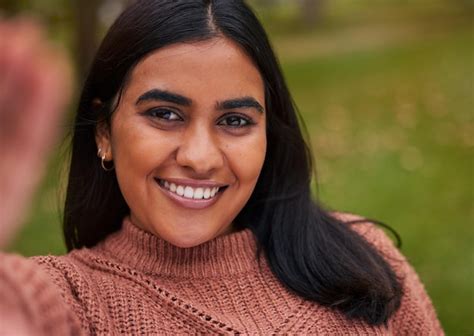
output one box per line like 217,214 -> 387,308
126,38 -> 264,104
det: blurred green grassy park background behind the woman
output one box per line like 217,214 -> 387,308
0,0 -> 474,335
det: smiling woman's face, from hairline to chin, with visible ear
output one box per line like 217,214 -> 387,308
96,39 -> 266,247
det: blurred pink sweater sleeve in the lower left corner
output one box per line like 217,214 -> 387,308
0,253 -> 81,335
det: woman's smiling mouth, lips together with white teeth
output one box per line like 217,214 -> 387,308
155,178 -> 227,209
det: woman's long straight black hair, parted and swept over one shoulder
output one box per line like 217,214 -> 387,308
63,0 -> 402,325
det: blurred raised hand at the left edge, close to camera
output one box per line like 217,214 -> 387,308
0,19 -> 71,248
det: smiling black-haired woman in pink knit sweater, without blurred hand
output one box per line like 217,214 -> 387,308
1,0 -> 442,335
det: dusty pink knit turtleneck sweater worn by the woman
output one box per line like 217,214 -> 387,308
0,214 -> 443,335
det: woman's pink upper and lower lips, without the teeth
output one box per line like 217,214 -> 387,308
154,177 -> 225,209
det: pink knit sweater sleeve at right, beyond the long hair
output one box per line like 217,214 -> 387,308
344,217 -> 444,335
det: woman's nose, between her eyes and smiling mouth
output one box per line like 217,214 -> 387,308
176,126 -> 224,175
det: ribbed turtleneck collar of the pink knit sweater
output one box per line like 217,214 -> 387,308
98,217 -> 258,278
